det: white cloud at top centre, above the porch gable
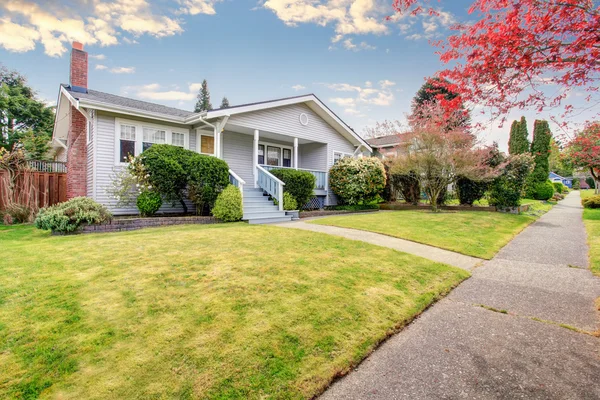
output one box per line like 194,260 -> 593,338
263,0 -> 390,43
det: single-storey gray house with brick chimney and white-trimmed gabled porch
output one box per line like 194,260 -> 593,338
53,42 -> 372,222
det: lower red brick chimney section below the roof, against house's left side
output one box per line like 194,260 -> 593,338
67,106 -> 87,200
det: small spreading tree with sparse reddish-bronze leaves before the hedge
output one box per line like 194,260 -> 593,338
394,103 -> 491,212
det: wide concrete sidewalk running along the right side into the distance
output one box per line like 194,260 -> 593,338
296,192 -> 600,400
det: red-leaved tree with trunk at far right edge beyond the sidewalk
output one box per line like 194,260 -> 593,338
567,122 -> 600,193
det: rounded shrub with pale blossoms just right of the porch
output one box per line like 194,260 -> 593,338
329,157 -> 386,204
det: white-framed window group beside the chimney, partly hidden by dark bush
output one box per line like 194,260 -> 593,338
115,118 -> 189,165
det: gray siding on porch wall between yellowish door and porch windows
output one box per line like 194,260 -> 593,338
222,131 -> 254,185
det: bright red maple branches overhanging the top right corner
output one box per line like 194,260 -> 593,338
393,0 -> 600,125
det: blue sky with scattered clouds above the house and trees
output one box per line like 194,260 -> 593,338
0,0 -> 592,148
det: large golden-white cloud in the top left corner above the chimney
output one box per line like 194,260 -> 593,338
0,0 -> 219,56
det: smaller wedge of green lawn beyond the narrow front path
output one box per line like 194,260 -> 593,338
311,209 -> 551,259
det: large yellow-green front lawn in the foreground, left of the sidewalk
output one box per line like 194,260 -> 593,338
0,224 -> 468,399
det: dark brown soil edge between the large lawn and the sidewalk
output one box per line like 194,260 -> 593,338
310,274 -> 473,400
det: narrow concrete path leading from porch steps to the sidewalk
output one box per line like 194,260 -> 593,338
277,217 -> 483,271
